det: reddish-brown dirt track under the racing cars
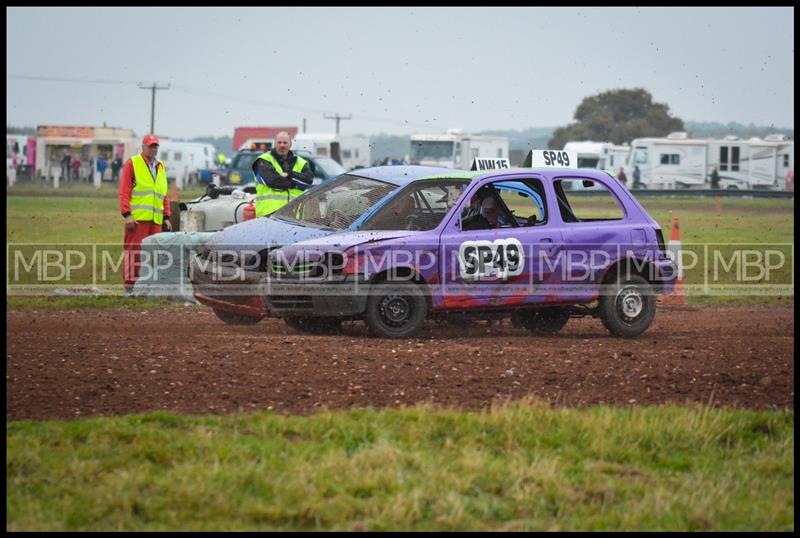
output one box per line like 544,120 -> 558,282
6,305 -> 794,420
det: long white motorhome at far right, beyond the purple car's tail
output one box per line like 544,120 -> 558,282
625,132 -> 794,190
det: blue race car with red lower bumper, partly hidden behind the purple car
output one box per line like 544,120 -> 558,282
189,166 -> 460,322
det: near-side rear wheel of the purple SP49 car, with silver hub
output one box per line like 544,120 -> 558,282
598,275 -> 656,338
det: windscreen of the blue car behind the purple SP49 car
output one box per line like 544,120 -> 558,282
273,174 -> 397,230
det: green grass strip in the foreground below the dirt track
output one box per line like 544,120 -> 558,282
6,402 -> 794,531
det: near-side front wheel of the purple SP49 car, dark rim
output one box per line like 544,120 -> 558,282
364,282 -> 428,338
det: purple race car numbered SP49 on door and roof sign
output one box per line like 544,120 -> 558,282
263,151 -> 677,338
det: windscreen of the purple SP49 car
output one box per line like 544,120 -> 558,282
361,179 -> 469,230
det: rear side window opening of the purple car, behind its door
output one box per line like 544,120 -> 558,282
554,178 -> 625,222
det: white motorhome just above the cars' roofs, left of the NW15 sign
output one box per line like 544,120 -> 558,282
410,129 -> 509,170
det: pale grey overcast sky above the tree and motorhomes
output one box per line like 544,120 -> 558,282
6,7 -> 794,137
